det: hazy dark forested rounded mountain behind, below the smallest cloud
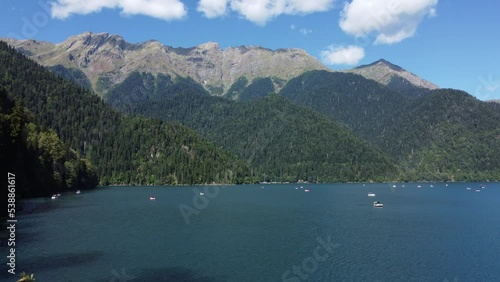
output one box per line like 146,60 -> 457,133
280,71 -> 410,137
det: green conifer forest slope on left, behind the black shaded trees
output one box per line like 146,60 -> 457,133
0,43 -> 250,187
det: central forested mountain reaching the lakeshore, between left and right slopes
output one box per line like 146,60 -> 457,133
119,91 -> 397,182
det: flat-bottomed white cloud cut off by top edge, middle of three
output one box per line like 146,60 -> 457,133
198,0 -> 334,25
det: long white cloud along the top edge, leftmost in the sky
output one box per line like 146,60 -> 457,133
51,0 -> 187,20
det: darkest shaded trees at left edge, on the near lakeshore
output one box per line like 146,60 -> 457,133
0,87 -> 97,197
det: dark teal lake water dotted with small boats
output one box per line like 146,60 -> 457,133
0,183 -> 500,282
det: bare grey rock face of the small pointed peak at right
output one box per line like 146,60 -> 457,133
345,59 -> 439,90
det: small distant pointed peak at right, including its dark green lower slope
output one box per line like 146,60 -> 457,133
344,59 -> 439,94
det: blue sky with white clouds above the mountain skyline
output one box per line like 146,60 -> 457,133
0,0 -> 500,100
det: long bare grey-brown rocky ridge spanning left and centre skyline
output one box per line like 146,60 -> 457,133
1,32 -> 327,96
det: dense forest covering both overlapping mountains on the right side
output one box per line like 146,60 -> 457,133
281,71 -> 500,181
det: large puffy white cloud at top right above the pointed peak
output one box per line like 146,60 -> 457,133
340,0 -> 439,44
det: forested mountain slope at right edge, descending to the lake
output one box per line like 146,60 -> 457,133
375,89 -> 500,181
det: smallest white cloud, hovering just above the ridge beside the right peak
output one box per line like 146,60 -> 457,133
321,45 -> 365,65
